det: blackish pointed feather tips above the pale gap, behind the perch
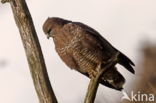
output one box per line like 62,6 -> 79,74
119,53 -> 135,74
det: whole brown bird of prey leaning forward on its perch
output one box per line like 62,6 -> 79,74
43,17 -> 134,90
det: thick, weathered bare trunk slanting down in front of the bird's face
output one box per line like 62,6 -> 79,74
1,0 -> 57,103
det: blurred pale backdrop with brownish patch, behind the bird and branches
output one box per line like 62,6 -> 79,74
0,0 -> 156,103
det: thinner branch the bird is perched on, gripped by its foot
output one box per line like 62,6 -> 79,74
84,52 -> 119,103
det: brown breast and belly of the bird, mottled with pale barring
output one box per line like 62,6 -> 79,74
52,23 -> 103,73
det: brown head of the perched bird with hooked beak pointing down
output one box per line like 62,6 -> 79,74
43,17 -> 70,39
